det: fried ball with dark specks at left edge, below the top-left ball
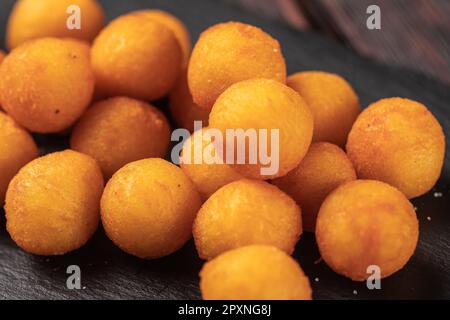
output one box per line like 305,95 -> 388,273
0,38 -> 94,133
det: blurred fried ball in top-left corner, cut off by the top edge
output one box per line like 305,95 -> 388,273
6,0 -> 104,49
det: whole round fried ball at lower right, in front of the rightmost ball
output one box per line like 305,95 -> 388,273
316,180 -> 419,281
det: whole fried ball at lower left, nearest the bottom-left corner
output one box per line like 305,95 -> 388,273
5,150 -> 103,255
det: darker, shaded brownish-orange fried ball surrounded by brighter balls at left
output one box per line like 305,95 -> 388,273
70,97 -> 170,179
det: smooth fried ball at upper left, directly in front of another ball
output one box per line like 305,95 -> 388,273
91,15 -> 183,100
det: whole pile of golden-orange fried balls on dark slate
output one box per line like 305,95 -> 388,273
0,0 -> 445,299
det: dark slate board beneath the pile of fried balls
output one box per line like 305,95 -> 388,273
0,0 -> 450,299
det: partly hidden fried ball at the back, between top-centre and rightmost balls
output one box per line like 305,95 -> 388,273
287,71 -> 360,147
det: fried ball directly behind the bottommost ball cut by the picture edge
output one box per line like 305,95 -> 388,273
194,179 -> 302,260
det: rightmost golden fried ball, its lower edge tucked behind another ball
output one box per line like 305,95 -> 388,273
347,98 -> 445,199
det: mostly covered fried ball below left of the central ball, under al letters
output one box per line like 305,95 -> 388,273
181,128 -> 243,200
